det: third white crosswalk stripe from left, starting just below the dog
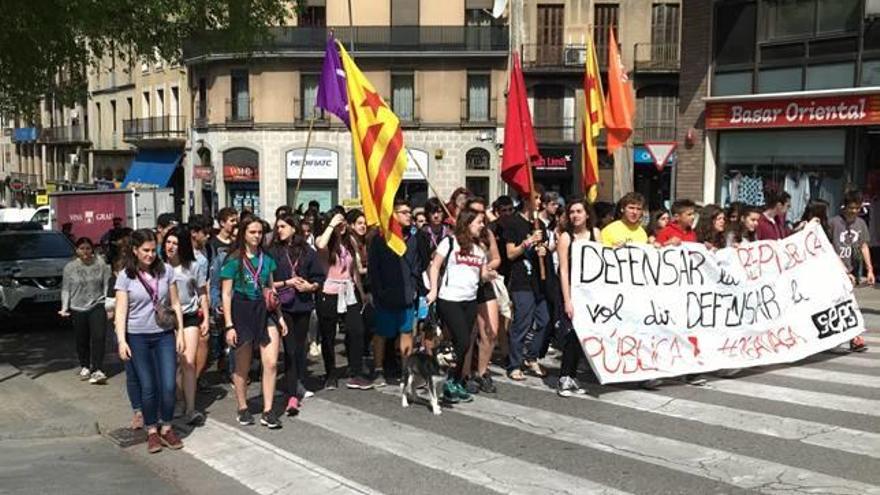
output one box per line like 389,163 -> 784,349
374,391 -> 880,495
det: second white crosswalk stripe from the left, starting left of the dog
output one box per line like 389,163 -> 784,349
297,399 -> 626,495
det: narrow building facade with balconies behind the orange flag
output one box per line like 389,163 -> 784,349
521,0 -> 681,208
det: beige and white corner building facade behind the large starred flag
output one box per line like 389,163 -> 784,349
184,0 -> 509,215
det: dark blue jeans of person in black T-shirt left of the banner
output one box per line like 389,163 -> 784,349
507,290 -> 550,372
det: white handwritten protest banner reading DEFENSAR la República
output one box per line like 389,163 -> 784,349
571,224 -> 865,384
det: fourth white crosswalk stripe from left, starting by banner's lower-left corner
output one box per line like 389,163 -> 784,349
484,367 -> 880,459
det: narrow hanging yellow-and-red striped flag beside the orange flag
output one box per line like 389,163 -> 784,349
581,38 -> 605,203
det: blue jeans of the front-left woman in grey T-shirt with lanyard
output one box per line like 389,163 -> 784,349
128,331 -> 177,427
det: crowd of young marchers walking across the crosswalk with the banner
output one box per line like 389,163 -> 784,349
60,188 -> 874,452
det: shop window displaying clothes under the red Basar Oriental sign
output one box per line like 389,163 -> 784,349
718,129 -> 847,219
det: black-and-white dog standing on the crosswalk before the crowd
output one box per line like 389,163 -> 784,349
400,343 -> 455,415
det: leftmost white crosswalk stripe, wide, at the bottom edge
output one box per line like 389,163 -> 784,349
184,419 -> 382,495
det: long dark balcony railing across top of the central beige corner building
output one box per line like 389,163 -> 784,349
183,26 -> 510,59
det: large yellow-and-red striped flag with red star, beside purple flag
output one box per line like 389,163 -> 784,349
337,42 -> 407,255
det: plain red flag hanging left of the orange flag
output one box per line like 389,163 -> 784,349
501,53 -> 541,197
